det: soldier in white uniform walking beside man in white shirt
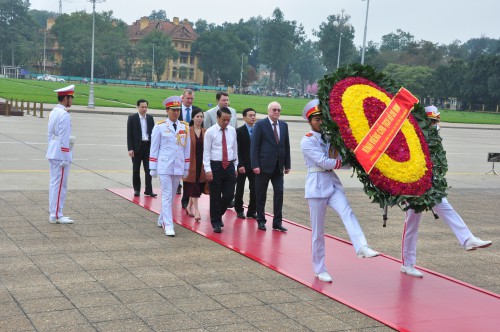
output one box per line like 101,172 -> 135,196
149,96 -> 190,236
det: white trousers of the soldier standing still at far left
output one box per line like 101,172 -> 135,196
49,159 -> 70,219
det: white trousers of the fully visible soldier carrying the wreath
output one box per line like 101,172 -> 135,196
307,189 -> 367,273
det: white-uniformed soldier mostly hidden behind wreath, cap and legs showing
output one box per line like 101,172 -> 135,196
401,106 -> 492,278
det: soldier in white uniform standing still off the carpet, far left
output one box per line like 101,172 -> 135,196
46,85 -> 75,224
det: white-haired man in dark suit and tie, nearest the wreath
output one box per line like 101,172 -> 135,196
250,101 -> 291,232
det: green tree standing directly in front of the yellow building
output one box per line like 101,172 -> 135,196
136,30 -> 182,81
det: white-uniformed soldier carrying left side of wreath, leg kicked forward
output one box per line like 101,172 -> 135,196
300,99 -> 379,282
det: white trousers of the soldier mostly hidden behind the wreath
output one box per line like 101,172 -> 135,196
401,198 -> 472,265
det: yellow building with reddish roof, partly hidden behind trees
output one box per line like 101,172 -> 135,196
128,17 -> 203,84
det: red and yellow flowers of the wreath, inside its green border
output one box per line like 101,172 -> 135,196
330,77 -> 432,196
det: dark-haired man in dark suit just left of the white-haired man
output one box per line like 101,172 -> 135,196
234,108 -> 257,219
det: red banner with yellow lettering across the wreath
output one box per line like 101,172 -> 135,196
354,88 -> 418,174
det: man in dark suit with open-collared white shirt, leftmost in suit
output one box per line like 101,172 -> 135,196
127,99 -> 156,197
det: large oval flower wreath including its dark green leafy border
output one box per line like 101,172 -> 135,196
318,64 -> 447,212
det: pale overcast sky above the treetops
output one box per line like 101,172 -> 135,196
30,0 -> 500,45
